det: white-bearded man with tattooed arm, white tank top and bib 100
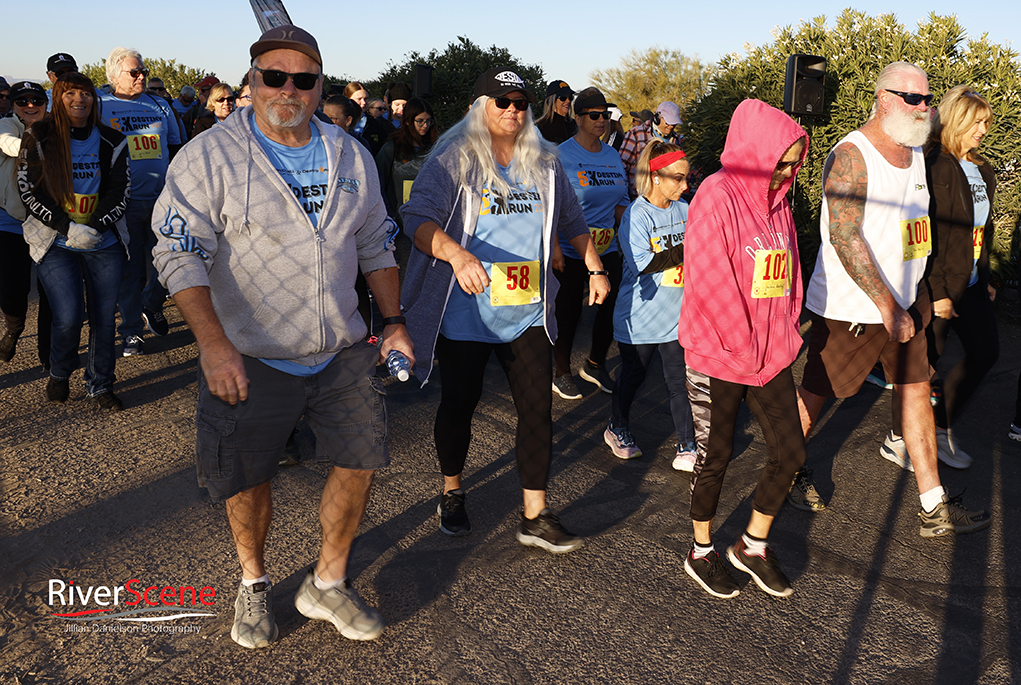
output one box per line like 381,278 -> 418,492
787,62 -> 989,538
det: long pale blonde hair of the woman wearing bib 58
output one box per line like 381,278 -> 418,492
432,95 -> 557,195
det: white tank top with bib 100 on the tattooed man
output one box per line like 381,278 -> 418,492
805,131 -> 932,324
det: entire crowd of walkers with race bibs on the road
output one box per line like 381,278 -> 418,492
0,27 -> 1021,648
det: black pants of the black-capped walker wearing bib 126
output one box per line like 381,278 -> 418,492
553,252 -> 622,376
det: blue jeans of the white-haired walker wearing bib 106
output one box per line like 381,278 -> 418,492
117,199 -> 166,340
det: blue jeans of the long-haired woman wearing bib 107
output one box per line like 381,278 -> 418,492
37,242 -> 125,397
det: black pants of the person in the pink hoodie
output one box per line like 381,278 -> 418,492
691,366 -> 805,521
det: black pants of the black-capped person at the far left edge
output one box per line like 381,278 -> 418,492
0,231 -> 53,364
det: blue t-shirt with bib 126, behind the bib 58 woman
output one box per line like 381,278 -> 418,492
560,138 -> 628,259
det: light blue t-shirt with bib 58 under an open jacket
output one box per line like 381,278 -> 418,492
440,166 -> 542,343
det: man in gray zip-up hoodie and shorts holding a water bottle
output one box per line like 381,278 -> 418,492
153,26 -> 415,648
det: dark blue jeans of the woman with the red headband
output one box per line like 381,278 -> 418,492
611,340 -> 695,447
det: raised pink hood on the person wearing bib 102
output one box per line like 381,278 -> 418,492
720,100 -> 809,213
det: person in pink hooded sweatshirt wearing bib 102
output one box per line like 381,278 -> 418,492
679,100 -> 809,597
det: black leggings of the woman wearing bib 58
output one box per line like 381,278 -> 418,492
433,326 -> 553,490
